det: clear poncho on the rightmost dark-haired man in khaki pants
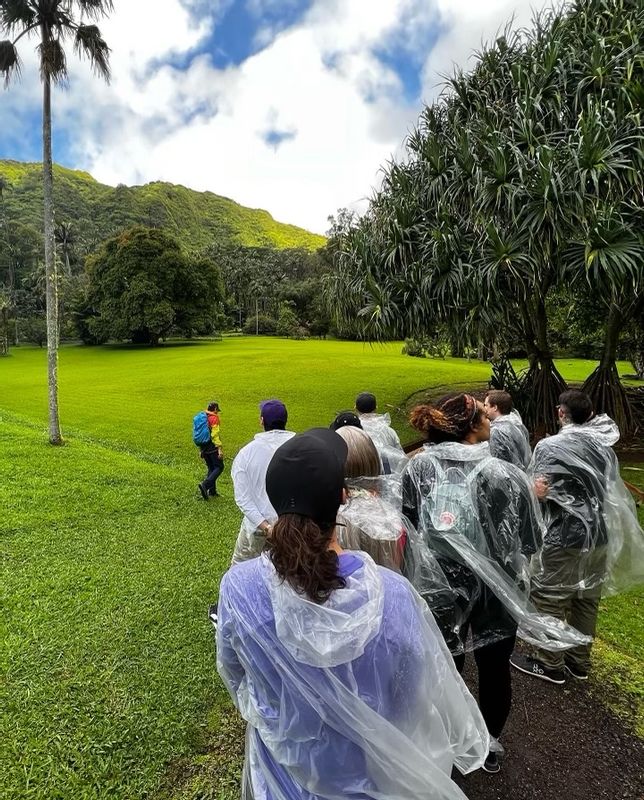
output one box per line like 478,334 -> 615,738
529,414 -> 644,599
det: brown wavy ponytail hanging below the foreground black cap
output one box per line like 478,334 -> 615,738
266,514 -> 346,603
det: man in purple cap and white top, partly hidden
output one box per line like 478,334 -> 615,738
230,399 -> 295,564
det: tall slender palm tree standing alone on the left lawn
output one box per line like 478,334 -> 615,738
0,0 -> 113,445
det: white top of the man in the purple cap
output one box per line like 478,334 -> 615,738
230,430 -> 295,531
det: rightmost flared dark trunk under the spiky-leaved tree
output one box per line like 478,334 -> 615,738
582,303 -> 635,436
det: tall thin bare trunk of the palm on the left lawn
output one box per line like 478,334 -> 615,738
42,72 -> 63,445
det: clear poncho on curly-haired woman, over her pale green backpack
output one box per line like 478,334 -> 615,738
403,442 -> 590,654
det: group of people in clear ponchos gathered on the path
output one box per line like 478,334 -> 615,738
197,390 -> 644,800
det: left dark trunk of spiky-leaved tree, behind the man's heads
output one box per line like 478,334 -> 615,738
521,297 -> 567,437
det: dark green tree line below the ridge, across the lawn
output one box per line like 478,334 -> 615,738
0,208 -> 335,352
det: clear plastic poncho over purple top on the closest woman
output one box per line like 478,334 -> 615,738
217,553 -> 489,800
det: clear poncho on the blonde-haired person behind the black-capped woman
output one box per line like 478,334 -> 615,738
336,474 -> 456,613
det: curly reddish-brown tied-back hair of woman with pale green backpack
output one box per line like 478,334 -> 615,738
409,394 -> 483,444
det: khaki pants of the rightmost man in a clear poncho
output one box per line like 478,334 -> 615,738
530,547 -> 606,672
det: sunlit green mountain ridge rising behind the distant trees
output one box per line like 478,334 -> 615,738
0,160 -> 325,250
